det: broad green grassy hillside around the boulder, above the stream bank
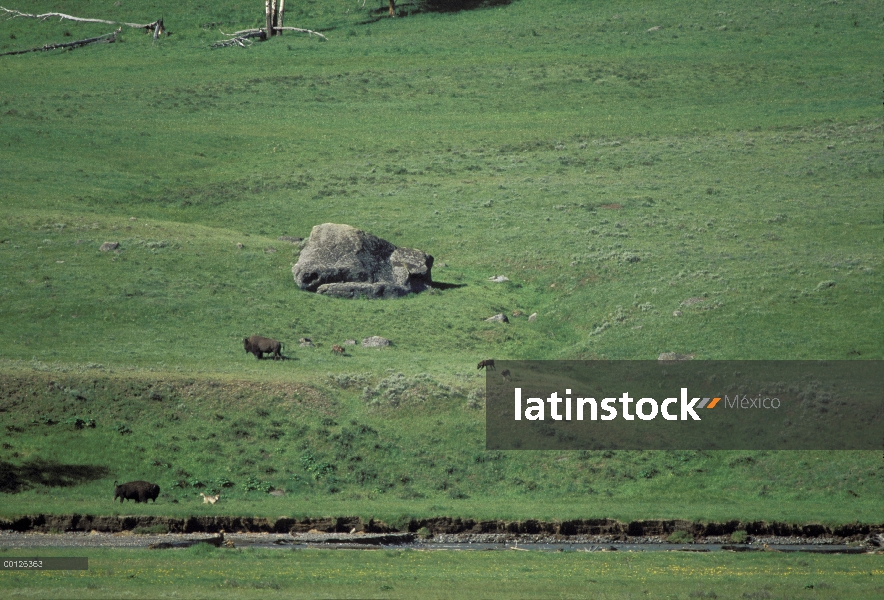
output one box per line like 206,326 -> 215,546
0,0 -> 884,522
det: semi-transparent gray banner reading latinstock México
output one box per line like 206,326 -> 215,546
485,360 -> 884,450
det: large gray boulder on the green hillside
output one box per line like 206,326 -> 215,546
292,223 -> 433,298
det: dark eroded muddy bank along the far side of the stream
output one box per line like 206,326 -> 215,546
0,514 -> 884,542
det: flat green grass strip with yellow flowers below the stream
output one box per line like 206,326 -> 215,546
0,545 -> 884,600
